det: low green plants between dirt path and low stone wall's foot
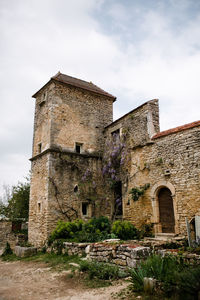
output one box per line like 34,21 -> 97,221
80,261 -> 124,280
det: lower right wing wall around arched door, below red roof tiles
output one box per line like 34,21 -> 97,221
124,123 -> 200,235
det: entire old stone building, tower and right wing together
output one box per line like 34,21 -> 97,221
29,73 -> 200,246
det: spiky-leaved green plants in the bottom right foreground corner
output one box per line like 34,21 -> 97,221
130,255 -> 200,300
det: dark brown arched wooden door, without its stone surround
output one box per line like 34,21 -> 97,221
158,187 -> 175,233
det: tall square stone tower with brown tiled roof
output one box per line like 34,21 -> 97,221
29,73 -> 116,246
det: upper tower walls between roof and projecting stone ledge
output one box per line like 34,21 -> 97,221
33,83 -> 113,156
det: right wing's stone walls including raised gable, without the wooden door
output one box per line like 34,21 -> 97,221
105,100 -> 200,235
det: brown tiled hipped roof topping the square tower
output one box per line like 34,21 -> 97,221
33,72 -> 116,101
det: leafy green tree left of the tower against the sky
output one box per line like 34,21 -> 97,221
0,178 -> 30,220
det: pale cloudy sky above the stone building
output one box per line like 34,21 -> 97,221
0,0 -> 200,195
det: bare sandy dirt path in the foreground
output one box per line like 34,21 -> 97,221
0,261 -> 130,300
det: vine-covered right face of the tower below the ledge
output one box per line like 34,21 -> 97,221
48,152 -> 111,238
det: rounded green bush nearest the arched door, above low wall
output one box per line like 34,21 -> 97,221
112,221 -> 139,240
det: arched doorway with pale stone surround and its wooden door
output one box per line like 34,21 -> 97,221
151,180 -> 177,233
